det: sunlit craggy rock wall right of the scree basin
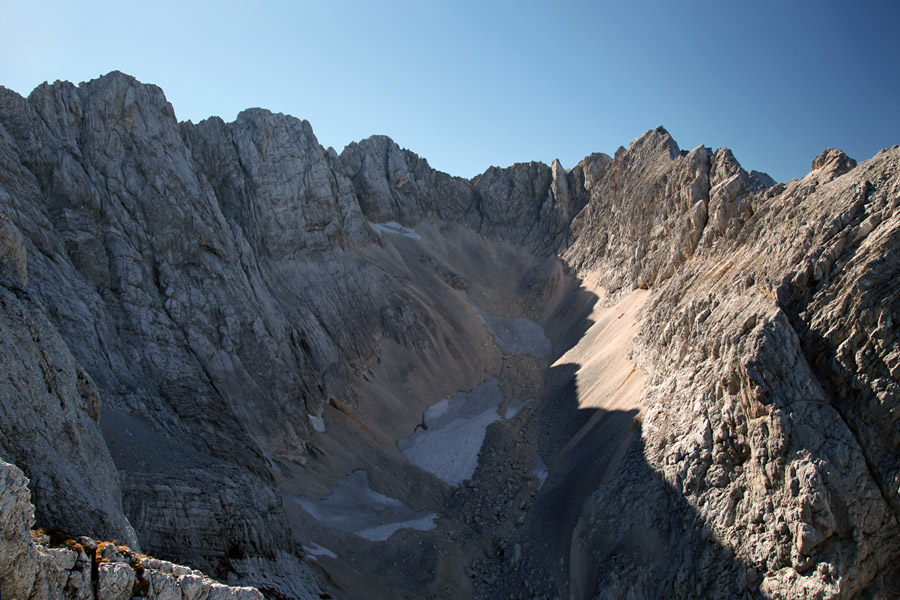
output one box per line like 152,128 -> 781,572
568,143 -> 900,598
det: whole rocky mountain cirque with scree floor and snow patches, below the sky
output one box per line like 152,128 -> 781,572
0,73 -> 900,599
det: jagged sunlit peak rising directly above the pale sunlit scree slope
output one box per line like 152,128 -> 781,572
563,127 -> 774,291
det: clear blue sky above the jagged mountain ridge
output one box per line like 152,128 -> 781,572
0,0 -> 900,181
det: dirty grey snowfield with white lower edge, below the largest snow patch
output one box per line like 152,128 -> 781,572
286,471 -> 437,542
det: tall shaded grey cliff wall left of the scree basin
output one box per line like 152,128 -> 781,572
0,73 -> 574,596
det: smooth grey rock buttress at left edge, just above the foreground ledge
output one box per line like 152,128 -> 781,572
0,218 -> 138,547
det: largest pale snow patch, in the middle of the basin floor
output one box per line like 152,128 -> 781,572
397,377 -> 503,486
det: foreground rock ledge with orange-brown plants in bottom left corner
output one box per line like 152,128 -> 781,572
0,461 -> 263,600
